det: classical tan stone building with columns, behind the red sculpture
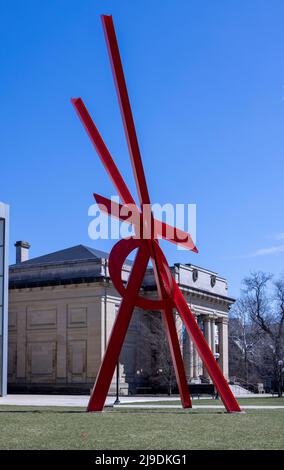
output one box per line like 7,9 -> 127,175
8,242 -> 234,394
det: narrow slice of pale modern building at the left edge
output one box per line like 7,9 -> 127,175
0,202 -> 9,396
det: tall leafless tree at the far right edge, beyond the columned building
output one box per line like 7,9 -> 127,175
241,272 -> 284,396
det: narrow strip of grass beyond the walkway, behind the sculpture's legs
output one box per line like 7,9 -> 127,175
127,397 -> 284,407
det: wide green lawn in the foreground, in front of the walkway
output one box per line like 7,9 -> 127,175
0,400 -> 284,450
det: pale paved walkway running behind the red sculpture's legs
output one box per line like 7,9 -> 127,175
0,395 -> 284,409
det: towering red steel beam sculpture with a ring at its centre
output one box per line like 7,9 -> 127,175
71,15 -> 241,412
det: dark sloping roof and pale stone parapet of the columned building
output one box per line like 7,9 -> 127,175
9,245 -> 234,302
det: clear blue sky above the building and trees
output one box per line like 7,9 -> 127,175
0,0 -> 284,296
